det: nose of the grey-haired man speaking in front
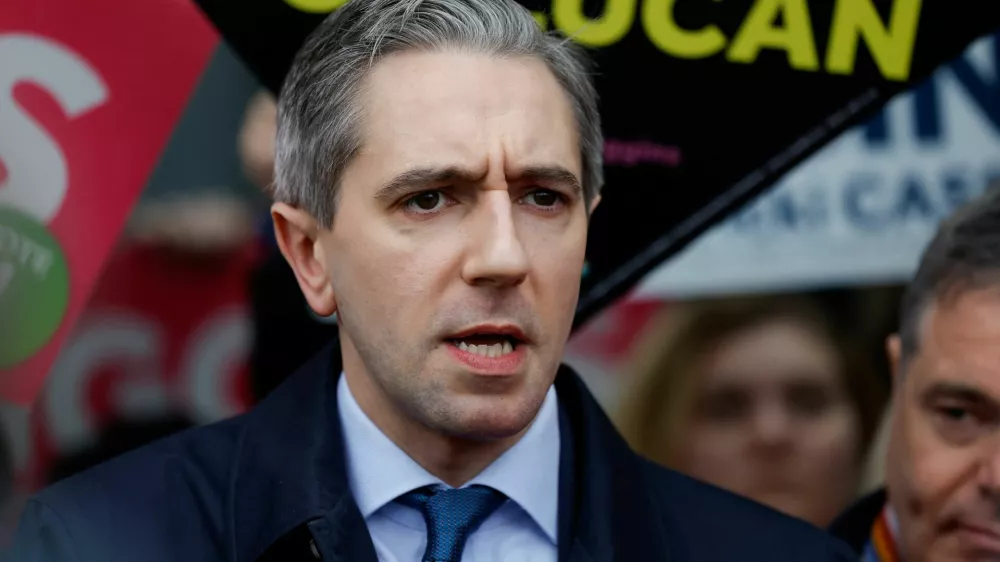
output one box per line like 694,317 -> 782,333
462,189 -> 528,287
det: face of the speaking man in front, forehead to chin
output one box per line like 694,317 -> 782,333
317,52 -> 587,439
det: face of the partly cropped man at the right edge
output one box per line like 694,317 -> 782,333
887,287 -> 1000,562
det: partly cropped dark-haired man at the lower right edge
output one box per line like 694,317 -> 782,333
833,187 -> 1000,562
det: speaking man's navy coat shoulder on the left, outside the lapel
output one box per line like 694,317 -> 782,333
13,417 -> 245,560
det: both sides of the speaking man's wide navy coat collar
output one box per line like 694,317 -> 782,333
227,345 -> 668,562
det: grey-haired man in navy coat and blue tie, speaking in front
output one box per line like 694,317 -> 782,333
7,0 -> 846,562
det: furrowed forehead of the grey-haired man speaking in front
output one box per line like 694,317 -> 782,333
358,52 -> 582,190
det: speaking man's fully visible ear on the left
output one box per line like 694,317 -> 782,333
271,203 -> 337,317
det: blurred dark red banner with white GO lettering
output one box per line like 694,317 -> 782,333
18,243 -> 257,490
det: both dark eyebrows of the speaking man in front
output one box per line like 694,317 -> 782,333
375,165 -> 583,201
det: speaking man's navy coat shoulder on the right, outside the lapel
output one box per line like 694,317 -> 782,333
642,459 -> 854,562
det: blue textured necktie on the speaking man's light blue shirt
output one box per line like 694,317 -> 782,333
398,486 -> 507,562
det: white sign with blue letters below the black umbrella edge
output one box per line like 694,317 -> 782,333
636,35 -> 1000,297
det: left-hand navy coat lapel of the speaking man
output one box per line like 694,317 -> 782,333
227,344 -> 376,562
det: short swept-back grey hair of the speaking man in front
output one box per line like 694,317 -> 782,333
272,0 -> 604,228
